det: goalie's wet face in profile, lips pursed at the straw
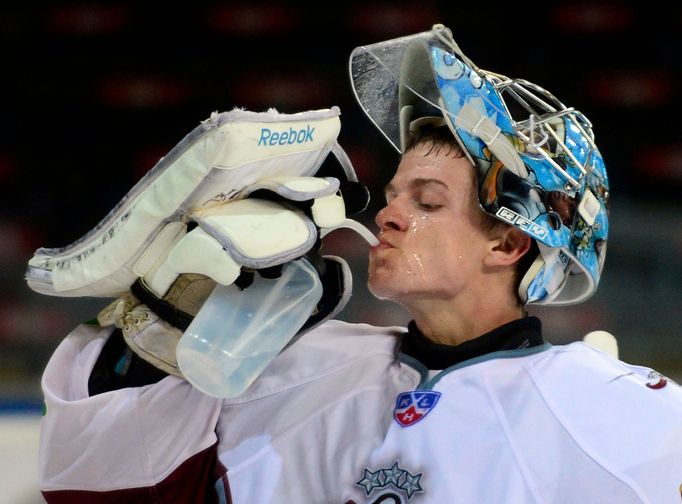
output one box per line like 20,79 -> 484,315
369,144 -> 490,308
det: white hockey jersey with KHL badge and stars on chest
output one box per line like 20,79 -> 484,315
40,321 -> 682,504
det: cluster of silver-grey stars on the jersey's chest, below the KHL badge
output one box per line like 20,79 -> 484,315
349,461 -> 424,503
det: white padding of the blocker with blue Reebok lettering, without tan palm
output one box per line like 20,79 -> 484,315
26,107 -> 366,297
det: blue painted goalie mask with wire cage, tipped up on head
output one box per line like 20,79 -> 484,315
350,25 -> 609,305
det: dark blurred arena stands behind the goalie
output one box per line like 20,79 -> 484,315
0,0 -> 682,504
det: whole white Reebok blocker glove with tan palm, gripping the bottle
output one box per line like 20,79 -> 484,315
26,107 -> 374,376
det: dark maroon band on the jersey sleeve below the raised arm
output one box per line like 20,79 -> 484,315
43,443 -> 232,504
